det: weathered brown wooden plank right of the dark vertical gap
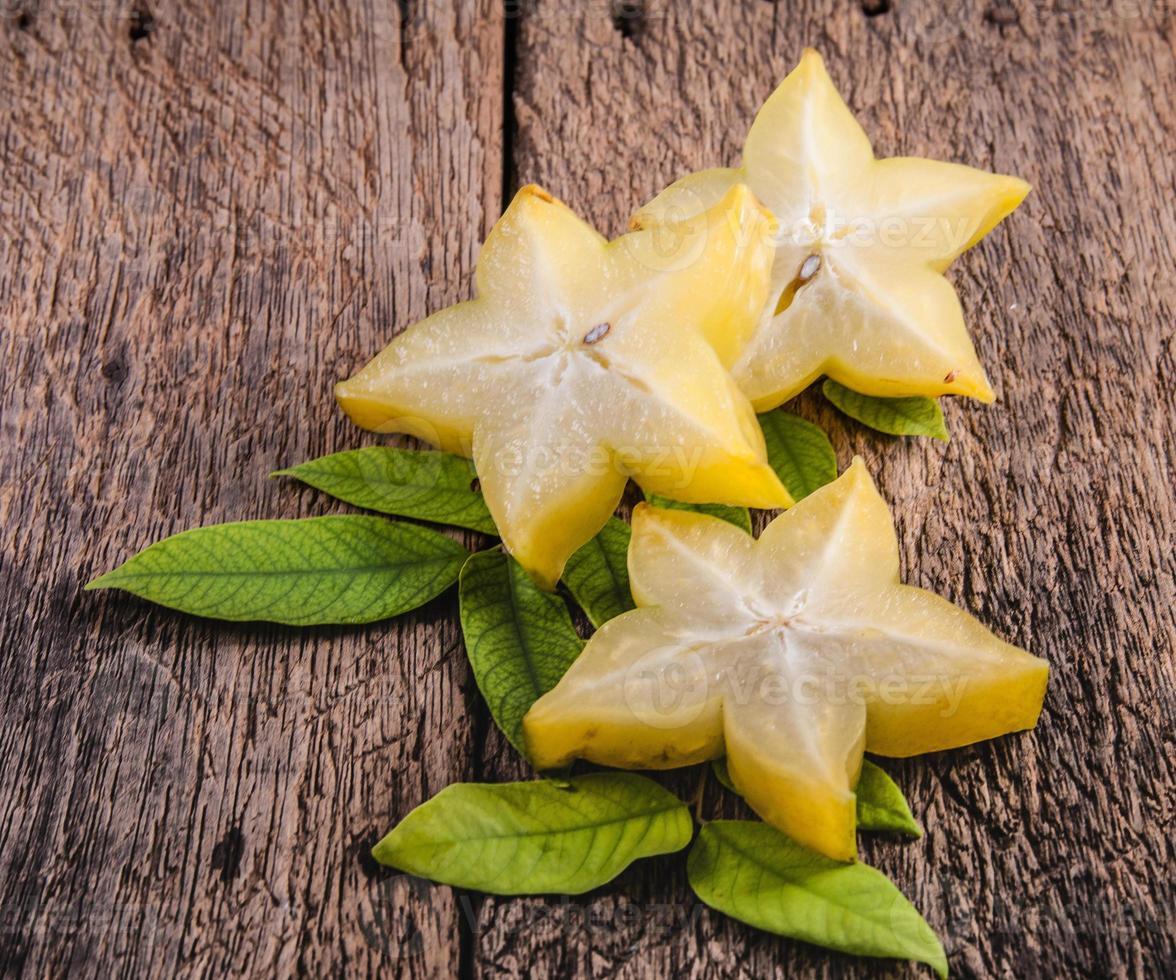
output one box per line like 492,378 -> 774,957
473,0 -> 1176,978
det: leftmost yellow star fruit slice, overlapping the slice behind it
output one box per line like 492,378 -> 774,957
335,185 -> 791,588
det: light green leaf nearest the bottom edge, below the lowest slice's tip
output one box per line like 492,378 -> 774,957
687,820 -> 948,976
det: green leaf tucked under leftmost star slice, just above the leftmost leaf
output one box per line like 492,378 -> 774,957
269,446 -> 499,534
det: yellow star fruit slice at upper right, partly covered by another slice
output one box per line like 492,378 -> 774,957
633,49 -> 1029,412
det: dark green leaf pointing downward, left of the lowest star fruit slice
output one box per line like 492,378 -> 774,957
457,548 -> 583,754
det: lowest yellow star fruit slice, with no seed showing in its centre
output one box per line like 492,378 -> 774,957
523,459 -> 1049,860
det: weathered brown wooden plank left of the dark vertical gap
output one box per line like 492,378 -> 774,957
0,0 -> 503,976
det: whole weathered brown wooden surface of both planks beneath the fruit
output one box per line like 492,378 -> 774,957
0,0 -> 1176,978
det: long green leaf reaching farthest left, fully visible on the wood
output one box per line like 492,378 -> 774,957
86,515 -> 468,626
